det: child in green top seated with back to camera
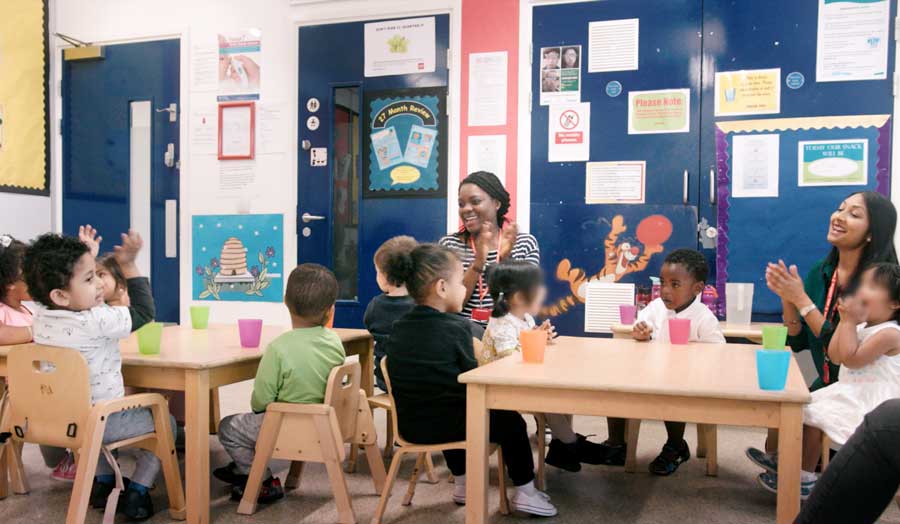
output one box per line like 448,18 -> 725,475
213,264 -> 346,503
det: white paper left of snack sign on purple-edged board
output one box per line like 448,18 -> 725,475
731,135 -> 778,198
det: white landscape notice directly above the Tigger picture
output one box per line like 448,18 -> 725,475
584,160 -> 647,204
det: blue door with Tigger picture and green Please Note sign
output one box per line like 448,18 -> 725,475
531,0 -> 713,335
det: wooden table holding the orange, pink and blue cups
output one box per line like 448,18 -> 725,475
459,337 -> 810,524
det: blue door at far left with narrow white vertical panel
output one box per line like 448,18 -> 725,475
62,40 -> 180,322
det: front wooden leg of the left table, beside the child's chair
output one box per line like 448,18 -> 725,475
184,369 -> 210,524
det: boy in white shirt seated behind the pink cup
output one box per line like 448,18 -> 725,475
601,249 -> 725,476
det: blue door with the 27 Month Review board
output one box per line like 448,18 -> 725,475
297,15 -> 450,327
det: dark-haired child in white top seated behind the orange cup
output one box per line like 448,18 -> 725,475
475,260 -> 603,472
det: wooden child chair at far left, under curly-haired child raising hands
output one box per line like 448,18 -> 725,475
0,344 -> 185,524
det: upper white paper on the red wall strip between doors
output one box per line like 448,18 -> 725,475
469,51 -> 507,127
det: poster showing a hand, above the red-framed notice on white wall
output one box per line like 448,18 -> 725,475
219,28 -> 262,102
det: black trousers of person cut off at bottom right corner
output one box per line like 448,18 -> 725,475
795,399 -> 900,524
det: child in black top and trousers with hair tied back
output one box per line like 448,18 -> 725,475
387,244 -> 556,516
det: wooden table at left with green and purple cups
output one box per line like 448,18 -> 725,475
0,325 -> 374,524
